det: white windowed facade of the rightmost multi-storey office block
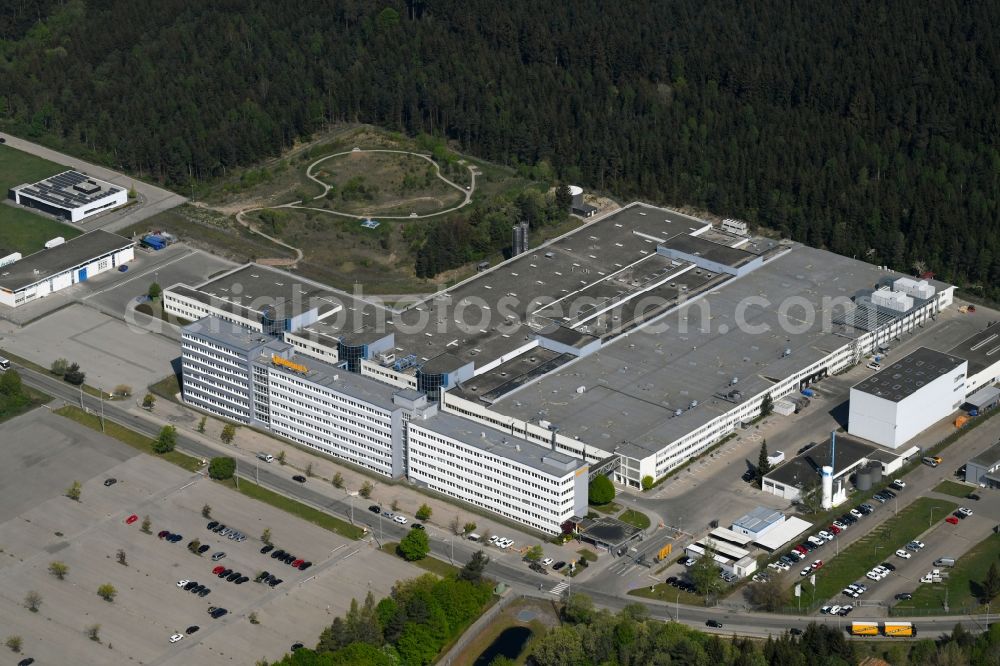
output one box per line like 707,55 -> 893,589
407,421 -> 588,533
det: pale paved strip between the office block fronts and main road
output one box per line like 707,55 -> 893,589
139,398 -> 581,562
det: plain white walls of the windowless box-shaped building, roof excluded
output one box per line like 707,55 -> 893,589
847,362 -> 969,449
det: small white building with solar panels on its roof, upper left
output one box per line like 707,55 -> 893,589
8,170 -> 128,222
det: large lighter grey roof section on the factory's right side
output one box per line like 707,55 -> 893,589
492,244 -> 908,457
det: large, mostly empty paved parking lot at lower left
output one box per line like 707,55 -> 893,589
0,412 -> 422,665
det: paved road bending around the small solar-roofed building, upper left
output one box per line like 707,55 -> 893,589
3,134 -> 187,231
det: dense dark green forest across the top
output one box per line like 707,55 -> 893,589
0,0 -> 1000,298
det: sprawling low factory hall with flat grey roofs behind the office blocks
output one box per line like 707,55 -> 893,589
172,204 -> 954,524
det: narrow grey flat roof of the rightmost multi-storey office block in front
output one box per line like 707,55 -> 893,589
413,412 -> 586,476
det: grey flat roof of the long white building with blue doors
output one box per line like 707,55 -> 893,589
0,229 -> 133,291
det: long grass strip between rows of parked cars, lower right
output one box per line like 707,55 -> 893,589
811,497 -> 958,603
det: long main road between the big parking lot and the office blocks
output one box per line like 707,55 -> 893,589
18,367 -> 984,636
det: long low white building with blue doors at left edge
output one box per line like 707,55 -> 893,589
0,229 -> 135,307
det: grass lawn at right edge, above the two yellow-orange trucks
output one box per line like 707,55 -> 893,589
895,534 -> 1000,612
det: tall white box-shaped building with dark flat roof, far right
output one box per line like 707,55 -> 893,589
848,347 -> 968,449
